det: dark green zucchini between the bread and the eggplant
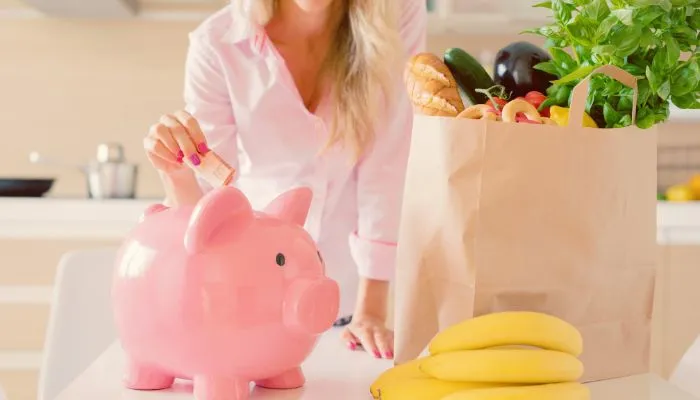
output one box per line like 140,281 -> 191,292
443,47 -> 496,107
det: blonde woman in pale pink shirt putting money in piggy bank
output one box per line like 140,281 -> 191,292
144,0 -> 427,358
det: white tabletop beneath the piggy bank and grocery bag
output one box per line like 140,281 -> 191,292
56,329 -> 698,400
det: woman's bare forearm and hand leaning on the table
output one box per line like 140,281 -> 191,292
342,278 -> 394,358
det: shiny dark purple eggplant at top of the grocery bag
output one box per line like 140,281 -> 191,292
493,42 -> 558,99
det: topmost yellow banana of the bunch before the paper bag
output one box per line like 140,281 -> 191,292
428,311 -> 583,357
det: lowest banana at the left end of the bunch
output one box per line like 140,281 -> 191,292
374,378 -> 503,400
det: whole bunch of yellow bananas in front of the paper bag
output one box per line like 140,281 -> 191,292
370,312 -> 590,400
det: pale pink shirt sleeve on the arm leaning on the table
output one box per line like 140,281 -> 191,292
350,0 -> 427,281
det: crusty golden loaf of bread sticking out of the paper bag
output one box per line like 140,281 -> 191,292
404,53 -> 464,117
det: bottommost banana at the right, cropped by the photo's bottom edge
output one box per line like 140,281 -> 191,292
441,382 -> 591,400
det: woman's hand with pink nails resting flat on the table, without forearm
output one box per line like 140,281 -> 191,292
343,315 -> 394,359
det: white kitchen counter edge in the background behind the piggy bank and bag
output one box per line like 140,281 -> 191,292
0,197 -> 700,244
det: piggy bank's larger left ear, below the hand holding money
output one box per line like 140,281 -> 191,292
185,186 -> 254,254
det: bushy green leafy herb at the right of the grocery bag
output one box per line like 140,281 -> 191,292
527,0 -> 700,128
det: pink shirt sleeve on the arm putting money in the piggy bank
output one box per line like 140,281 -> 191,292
184,31 -> 238,191
